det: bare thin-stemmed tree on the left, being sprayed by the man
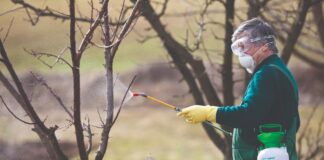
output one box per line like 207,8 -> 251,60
0,0 -> 142,160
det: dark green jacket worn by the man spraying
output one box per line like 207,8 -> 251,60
216,55 -> 300,160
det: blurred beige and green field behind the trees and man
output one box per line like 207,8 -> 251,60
0,0 -> 324,160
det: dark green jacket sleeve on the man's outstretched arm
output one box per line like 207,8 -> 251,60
216,66 -> 276,128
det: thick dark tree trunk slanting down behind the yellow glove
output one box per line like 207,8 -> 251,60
132,0 -> 230,156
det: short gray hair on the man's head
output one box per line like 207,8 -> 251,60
232,18 -> 278,53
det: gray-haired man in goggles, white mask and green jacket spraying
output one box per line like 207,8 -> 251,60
178,18 -> 300,160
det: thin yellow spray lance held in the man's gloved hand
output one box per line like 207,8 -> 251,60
132,93 -> 232,136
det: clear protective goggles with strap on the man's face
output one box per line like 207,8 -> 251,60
231,35 -> 274,56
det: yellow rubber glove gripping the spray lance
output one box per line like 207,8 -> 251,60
177,105 -> 218,124
